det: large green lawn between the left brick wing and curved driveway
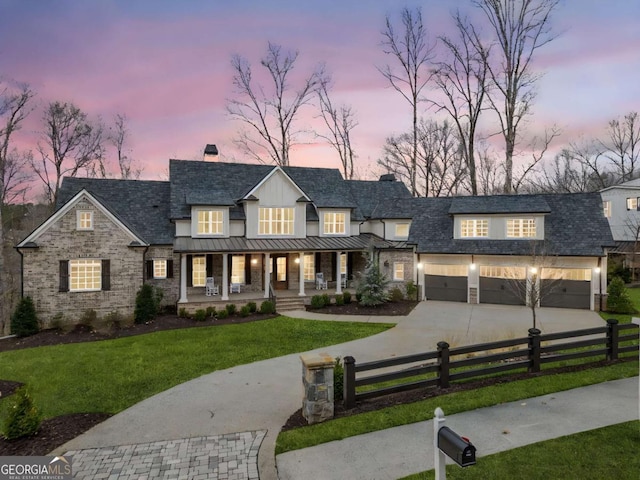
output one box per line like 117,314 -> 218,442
0,316 -> 393,417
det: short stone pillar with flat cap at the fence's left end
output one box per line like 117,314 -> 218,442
300,353 -> 335,424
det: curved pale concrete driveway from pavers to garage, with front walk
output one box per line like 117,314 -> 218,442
54,301 -> 603,480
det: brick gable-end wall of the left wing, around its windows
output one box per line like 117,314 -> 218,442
21,202 -> 144,328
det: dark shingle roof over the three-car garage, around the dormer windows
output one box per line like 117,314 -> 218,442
408,193 -> 615,256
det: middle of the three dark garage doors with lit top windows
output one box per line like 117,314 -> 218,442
480,265 -> 527,305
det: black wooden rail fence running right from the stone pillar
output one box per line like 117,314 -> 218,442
344,320 -> 639,408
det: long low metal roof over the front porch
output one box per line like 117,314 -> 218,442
174,233 -> 410,253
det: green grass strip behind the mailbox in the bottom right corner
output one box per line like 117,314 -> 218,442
403,420 -> 640,480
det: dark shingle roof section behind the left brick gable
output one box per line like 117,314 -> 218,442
57,177 -> 175,245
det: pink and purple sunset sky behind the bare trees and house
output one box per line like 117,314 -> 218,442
0,0 -> 640,187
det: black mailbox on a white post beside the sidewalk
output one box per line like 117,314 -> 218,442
433,407 -> 476,480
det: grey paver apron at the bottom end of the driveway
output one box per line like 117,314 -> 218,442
66,431 -> 267,480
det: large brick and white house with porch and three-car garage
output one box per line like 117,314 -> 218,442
17,160 -> 612,326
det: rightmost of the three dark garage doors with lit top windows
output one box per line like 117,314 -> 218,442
540,268 -> 591,309
